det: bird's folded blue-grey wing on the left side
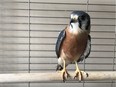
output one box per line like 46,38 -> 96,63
55,30 -> 66,58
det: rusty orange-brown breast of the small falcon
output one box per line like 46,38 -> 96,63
62,30 -> 87,61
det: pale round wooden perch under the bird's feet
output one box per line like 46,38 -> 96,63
0,71 -> 116,83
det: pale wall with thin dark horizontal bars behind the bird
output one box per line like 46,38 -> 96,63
0,0 -> 116,87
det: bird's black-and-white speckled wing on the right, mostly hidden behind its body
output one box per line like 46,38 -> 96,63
77,35 -> 91,62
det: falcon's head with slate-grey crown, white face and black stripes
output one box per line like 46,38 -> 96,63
70,11 -> 90,33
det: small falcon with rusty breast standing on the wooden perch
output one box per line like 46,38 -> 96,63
55,10 -> 91,81
